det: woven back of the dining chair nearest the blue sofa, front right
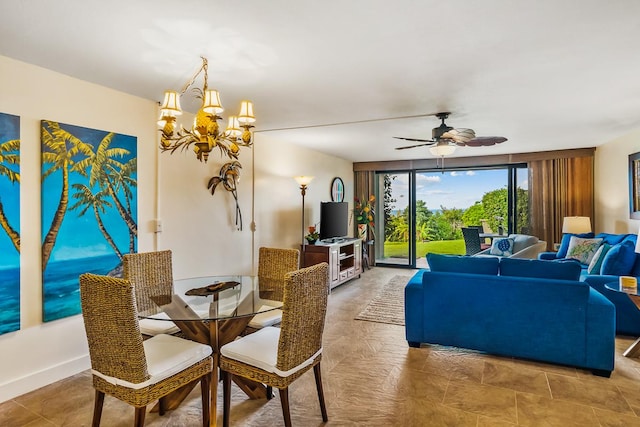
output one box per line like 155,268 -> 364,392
276,262 -> 329,371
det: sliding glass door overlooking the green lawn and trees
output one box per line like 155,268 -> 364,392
375,165 -> 529,268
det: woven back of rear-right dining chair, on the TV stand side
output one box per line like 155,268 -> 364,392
258,247 -> 300,301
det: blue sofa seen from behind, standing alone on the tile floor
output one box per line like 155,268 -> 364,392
405,254 -> 615,377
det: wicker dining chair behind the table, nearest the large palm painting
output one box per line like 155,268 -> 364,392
123,250 -> 180,336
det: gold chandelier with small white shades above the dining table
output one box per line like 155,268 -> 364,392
158,57 -> 256,163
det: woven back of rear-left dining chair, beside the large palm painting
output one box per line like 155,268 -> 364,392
123,250 -> 173,311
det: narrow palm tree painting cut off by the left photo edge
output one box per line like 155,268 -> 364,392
0,113 -> 20,334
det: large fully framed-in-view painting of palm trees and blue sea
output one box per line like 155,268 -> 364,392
41,120 -> 138,322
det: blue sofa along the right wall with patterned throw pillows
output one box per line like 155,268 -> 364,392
538,233 -> 640,336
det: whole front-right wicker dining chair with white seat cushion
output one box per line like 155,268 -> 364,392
220,262 -> 329,426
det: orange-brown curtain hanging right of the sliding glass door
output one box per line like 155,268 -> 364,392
529,156 -> 595,250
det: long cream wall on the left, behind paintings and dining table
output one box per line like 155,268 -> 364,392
0,56 -> 353,402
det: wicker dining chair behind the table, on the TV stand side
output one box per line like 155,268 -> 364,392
247,247 -> 300,332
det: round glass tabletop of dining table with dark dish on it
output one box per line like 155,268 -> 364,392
138,276 -> 282,321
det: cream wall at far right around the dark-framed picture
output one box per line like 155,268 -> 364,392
594,130 -> 640,233
